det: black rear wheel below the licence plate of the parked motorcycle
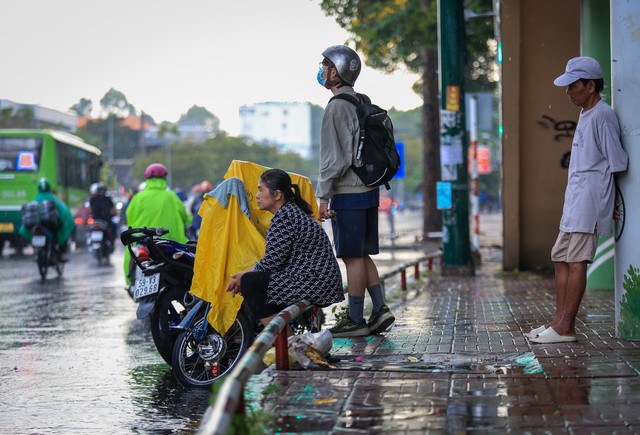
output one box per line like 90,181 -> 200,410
149,286 -> 193,365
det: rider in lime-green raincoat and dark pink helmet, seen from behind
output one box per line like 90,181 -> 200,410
124,163 -> 191,284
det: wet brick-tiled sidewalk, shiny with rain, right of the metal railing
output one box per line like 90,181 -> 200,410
236,215 -> 640,434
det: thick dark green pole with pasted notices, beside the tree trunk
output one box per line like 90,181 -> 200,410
438,0 -> 474,275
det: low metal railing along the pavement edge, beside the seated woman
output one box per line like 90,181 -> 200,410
197,251 -> 442,435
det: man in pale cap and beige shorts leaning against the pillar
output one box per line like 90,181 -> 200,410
527,56 -> 628,343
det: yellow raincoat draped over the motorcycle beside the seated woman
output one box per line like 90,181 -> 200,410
191,160 -> 318,335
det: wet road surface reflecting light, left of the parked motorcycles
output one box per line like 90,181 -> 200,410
0,249 -> 209,434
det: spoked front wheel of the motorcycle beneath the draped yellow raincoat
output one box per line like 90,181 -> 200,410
171,310 -> 255,388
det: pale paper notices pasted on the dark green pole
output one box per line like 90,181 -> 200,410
440,110 -> 464,181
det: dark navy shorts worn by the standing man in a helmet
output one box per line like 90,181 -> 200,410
331,189 -> 380,258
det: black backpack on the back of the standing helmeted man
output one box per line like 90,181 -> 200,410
329,94 -> 400,190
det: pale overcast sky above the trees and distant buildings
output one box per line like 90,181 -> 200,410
0,0 -> 421,135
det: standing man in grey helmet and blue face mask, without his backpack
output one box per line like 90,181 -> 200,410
316,45 -> 395,337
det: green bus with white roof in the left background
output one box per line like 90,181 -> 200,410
0,129 -> 103,255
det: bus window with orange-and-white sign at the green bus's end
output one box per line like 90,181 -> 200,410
0,137 -> 42,173
